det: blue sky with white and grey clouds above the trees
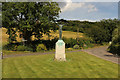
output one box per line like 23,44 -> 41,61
59,0 -> 118,22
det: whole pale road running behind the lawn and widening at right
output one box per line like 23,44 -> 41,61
3,46 -> 120,64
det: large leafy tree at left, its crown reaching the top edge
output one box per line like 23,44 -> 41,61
2,2 -> 60,43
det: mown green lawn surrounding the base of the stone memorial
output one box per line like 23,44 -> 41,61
3,52 -> 118,78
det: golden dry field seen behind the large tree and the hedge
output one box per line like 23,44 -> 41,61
0,28 -> 84,45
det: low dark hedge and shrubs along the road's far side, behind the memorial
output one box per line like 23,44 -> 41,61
3,37 -> 94,52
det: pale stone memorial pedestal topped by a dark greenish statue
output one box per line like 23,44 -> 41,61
55,25 -> 66,61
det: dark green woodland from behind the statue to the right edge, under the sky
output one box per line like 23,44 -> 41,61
59,19 -> 120,44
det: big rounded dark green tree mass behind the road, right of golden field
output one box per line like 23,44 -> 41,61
85,19 -> 120,44
